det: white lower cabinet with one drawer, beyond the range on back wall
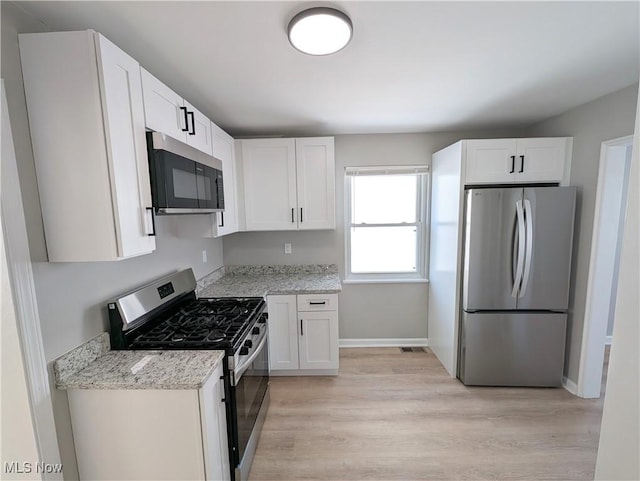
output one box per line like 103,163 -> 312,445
267,294 -> 339,376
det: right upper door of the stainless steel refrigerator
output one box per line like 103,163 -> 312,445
518,187 -> 576,311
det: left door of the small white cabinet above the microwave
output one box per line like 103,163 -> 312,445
140,68 -> 188,142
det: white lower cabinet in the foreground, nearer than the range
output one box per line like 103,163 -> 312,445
68,365 -> 231,480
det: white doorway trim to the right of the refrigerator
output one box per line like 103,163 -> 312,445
577,135 -> 633,398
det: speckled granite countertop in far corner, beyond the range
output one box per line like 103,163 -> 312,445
198,265 -> 342,297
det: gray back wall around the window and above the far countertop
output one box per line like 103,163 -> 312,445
224,129 -> 521,339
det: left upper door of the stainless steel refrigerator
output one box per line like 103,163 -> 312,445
462,188 -> 524,311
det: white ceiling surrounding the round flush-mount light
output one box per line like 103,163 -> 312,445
15,1 -> 640,136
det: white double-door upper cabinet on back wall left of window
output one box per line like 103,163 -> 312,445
239,137 -> 335,231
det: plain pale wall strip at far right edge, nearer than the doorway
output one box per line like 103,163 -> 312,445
595,82 -> 640,480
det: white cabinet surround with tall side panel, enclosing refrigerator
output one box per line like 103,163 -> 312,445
427,137 -> 573,377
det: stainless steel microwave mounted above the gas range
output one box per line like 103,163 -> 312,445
147,132 -> 224,215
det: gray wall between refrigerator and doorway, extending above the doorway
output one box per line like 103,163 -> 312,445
528,84 -> 638,382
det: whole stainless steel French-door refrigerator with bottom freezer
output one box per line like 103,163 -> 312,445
458,187 -> 576,386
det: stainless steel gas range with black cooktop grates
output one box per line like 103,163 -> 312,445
108,269 -> 269,481
